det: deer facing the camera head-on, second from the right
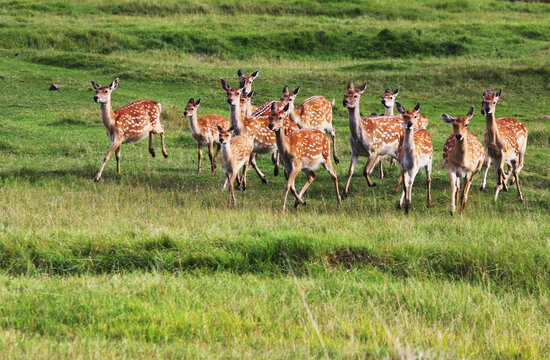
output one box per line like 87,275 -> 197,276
439,106 -> 485,215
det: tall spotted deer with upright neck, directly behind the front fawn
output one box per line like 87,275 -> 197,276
220,79 -> 298,183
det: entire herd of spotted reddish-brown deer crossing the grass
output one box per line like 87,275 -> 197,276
91,69 -> 527,215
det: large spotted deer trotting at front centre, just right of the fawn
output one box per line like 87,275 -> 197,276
269,104 -> 342,213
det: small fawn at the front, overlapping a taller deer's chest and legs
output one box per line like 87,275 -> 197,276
217,125 -> 253,206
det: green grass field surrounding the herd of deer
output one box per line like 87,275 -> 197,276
0,0 -> 550,359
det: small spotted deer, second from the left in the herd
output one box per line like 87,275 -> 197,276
183,98 -> 229,174
